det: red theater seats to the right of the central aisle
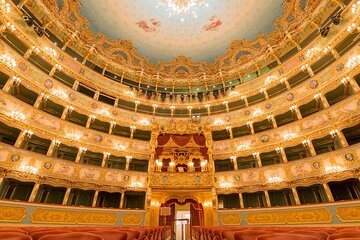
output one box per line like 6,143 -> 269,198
192,226 -> 360,240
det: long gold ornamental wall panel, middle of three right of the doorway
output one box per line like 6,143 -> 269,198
246,208 -> 333,225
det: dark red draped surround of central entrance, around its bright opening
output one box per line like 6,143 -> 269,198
159,198 -> 204,239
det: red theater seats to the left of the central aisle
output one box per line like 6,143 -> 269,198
0,227 -> 171,240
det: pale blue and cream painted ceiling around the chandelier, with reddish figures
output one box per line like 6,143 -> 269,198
80,0 -> 284,63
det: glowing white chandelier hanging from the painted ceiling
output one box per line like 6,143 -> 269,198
156,0 -> 209,22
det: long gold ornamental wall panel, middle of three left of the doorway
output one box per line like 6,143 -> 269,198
30,208 -> 117,225
